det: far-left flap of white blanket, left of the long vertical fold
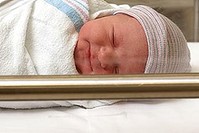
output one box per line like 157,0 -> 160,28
0,1 -> 36,74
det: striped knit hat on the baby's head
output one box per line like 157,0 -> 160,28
114,5 -> 191,73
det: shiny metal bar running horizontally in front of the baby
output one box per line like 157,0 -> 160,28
0,74 -> 199,101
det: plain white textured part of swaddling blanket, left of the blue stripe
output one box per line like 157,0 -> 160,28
0,0 -> 78,75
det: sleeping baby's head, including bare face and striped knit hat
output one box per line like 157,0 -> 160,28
74,5 -> 190,74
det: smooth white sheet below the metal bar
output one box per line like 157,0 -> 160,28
0,99 -> 199,133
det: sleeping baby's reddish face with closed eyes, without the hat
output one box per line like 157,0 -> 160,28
74,14 -> 148,74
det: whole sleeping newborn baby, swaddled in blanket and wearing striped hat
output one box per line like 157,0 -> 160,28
0,0 -> 190,75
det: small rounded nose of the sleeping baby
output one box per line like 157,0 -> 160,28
98,47 -> 117,68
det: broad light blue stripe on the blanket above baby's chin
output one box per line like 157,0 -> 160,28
45,0 -> 84,32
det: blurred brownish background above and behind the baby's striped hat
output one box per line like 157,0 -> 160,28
106,0 -> 199,42
